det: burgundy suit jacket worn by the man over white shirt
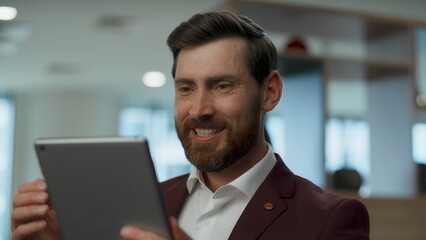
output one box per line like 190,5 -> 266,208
161,154 -> 370,240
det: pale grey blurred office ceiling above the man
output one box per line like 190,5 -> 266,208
0,0 -> 426,116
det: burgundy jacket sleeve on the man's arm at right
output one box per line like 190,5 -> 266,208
320,198 -> 370,240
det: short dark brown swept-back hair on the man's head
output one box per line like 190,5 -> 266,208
167,12 -> 277,85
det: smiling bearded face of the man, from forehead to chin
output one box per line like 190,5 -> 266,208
175,38 -> 263,172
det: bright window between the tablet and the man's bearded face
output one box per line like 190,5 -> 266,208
119,107 -> 191,181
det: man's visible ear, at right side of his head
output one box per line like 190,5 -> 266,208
262,70 -> 283,112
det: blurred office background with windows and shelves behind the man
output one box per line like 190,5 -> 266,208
0,0 -> 426,240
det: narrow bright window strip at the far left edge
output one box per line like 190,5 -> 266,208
0,95 -> 14,240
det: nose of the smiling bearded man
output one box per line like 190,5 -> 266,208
189,91 -> 215,120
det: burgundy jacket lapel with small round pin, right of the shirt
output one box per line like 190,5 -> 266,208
229,155 -> 294,240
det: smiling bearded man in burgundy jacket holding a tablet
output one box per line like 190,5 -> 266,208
12,13 -> 369,240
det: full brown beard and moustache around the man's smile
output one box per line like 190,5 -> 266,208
175,96 -> 261,172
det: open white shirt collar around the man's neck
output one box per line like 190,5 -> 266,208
186,143 -> 277,198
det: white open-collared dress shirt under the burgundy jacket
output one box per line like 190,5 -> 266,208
179,144 -> 277,240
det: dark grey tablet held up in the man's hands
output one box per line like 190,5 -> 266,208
35,137 -> 172,240
